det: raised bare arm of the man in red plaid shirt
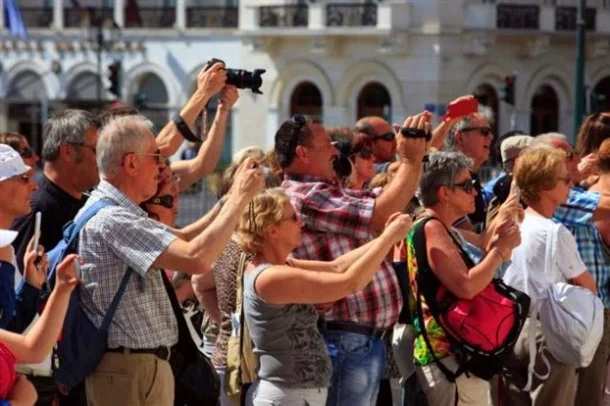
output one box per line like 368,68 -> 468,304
371,112 -> 430,232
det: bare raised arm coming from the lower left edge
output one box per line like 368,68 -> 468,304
0,254 -> 78,364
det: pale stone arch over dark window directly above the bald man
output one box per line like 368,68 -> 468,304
336,61 -> 406,123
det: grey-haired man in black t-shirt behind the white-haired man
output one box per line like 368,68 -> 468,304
11,109 -> 99,269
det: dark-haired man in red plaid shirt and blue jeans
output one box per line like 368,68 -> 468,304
275,113 -> 430,406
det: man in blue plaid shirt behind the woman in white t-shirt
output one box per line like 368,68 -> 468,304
530,133 -> 610,406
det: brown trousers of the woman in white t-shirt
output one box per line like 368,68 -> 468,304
499,318 -> 576,406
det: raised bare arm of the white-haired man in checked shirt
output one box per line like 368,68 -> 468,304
154,158 -> 265,274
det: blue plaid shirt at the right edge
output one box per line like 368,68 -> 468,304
553,188 -> 610,308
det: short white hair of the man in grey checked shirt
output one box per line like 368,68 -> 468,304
97,115 -> 151,179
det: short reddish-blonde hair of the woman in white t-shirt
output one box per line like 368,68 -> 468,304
514,146 -> 566,204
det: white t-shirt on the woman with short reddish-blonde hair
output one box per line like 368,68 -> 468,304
503,213 -> 587,302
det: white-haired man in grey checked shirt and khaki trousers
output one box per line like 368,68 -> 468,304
76,116 -> 264,406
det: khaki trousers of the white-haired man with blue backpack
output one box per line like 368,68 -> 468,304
85,352 -> 174,406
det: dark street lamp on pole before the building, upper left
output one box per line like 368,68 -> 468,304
88,8 -> 121,104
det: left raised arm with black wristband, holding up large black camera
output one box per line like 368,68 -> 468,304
156,63 -> 227,156
